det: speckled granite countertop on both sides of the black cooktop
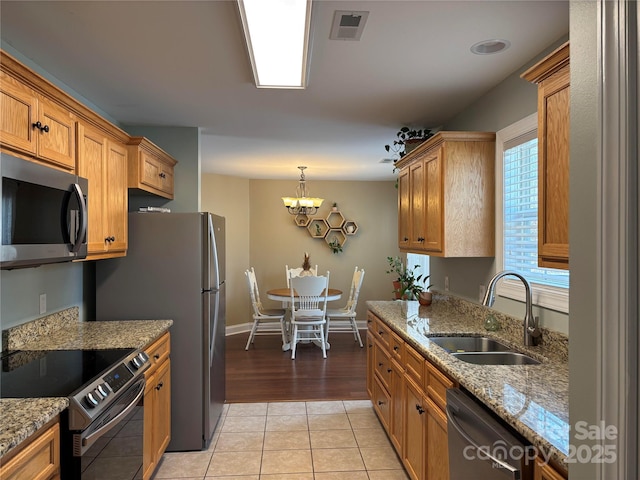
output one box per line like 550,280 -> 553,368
0,307 -> 173,457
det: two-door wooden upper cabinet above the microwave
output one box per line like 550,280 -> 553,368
0,72 -> 76,172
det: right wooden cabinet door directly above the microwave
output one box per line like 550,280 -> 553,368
36,98 -> 76,170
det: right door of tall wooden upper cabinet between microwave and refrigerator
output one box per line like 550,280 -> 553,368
105,141 -> 128,252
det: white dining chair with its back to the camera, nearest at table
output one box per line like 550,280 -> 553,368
289,272 -> 329,360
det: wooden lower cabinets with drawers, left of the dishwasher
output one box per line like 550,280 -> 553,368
367,312 -> 456,480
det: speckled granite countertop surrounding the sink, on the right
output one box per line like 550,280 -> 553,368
367,295 -> 569,468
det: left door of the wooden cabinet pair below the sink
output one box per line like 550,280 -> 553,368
402,375 -> 427,480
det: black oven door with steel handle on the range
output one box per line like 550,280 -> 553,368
62,377 -> 146,480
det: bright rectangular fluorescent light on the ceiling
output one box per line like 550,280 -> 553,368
238,0 -> 311,88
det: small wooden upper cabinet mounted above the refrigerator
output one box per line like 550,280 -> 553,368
128,137 -> 178,200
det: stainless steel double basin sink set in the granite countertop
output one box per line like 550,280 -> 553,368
429,336 -> 540,365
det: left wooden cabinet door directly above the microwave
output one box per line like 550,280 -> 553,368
0,73 -> 38,155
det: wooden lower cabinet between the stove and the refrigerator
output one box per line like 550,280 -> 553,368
142,333 -> 171,480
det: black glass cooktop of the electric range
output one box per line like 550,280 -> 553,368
0,348 -> 134,398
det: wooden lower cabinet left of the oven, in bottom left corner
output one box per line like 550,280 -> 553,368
0,419 -> 60,480
